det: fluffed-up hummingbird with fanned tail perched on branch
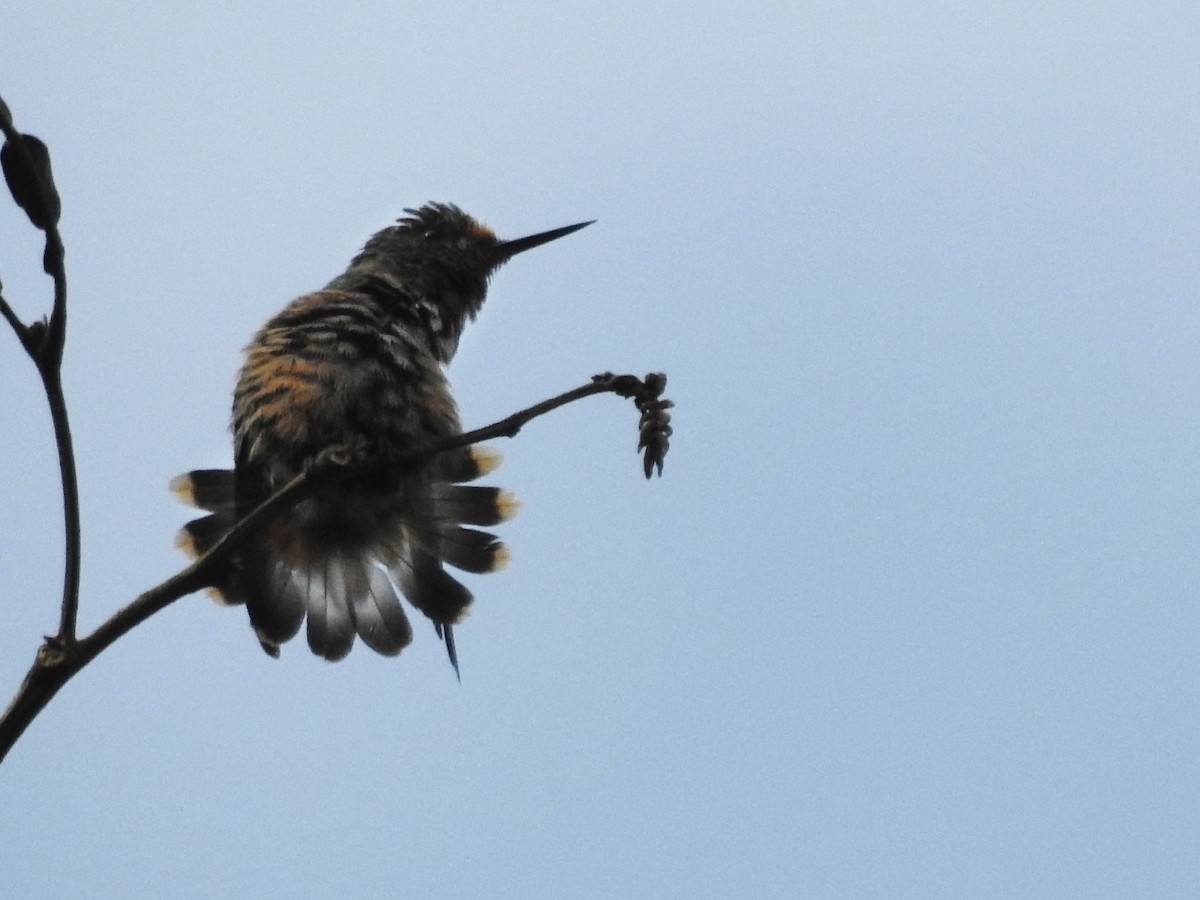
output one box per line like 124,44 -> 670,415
172,203 -> 590,673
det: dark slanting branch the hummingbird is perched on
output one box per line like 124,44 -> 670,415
0,373 -> 666,761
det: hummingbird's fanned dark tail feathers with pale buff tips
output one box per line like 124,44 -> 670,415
170,446 -> 518,672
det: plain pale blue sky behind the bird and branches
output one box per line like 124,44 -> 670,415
0,0 -> 1200,900
